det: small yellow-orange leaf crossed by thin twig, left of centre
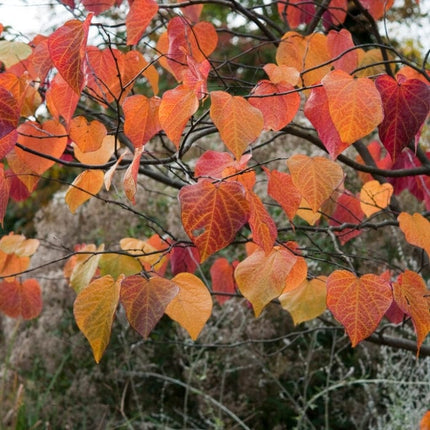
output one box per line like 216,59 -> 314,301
65,170 -> 104,214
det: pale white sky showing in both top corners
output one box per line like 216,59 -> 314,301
0,0 -> 430,52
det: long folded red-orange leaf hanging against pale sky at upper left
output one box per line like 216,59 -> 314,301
48,13 -> 92,94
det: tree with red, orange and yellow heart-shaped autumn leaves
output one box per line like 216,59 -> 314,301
0,0 -> 430,372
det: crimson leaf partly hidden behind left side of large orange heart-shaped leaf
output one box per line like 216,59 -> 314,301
304,87 -> 350,159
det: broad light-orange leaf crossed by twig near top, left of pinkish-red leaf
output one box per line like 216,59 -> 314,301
276,31 -> 331,86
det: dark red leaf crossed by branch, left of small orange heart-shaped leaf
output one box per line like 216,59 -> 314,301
329,193 -> 364,245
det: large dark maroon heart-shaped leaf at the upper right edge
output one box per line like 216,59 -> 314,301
375,75 -> 430,161
